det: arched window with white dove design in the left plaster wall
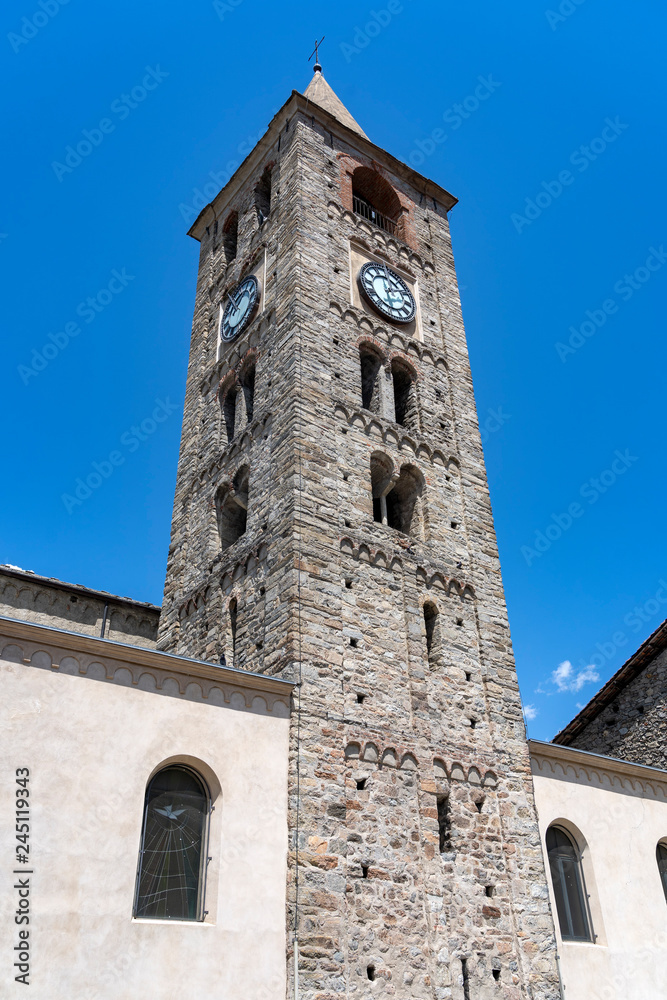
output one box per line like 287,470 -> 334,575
134,765 -> 210,920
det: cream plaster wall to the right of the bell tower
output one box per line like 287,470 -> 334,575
534,758 -> 667,1000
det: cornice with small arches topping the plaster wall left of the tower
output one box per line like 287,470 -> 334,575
0,616 -> 294,716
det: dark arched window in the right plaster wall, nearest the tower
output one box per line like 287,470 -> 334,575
547,826 -> 593,941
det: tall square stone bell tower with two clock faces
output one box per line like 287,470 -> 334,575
159,66 -> 560,1000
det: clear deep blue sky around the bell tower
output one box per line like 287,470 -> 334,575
0,0 -> 667,739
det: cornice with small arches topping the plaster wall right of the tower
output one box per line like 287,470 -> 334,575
528,740 -> 667,800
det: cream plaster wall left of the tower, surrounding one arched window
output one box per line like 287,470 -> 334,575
0,661 -> 289,1000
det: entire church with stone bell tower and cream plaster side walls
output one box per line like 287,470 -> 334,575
0,64 -> 667,1000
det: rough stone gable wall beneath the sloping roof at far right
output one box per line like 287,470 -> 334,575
569,650 -> 667,768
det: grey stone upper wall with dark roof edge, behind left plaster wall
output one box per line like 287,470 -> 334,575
0,566 -> 160,649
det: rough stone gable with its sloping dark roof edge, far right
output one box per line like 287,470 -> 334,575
553,622 -> 667,769
